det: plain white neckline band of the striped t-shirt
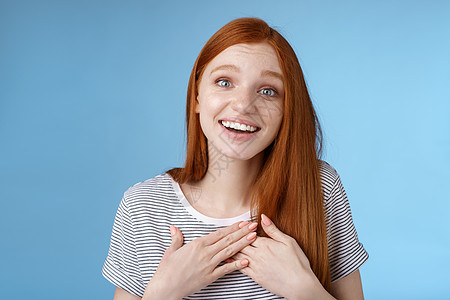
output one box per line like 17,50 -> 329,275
166,173 -> 251,226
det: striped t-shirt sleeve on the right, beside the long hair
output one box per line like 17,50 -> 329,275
325,175 -> 369,282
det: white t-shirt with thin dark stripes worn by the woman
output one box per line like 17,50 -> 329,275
102,162 -> 368,299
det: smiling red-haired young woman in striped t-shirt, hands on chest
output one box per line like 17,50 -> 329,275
102,18 -> 368,299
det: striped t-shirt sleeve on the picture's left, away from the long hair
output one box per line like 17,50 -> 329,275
102,197 -> 145,297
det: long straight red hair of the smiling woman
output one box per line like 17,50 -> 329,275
167,18 -> 330,290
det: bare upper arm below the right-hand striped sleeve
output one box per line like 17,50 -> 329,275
331,270 -> 364,300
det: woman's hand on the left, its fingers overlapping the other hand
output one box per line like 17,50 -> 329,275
142,221 -> 257,299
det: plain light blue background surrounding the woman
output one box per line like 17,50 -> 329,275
0,0 -> 450,300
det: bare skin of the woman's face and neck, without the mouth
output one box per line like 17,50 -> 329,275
181,44 -> 284,218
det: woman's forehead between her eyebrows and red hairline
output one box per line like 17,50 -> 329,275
206,43 -> 281,72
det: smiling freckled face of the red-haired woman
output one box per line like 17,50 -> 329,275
195,43 -> 284,160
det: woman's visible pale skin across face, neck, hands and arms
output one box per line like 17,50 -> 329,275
110,43 -> 364,300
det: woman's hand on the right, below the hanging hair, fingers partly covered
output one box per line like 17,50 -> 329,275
227,214 -> 333,299
